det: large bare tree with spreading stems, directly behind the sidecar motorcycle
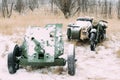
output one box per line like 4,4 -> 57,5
54,0 -> 79,18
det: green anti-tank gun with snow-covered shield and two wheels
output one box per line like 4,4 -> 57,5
8,24 -> 75,75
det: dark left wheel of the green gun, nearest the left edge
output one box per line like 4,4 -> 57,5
8,53 -> 16,74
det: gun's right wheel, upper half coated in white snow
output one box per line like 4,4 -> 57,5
67,44 -> 75,76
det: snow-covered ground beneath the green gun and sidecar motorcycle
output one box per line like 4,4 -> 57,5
0,32 -> 120,80
